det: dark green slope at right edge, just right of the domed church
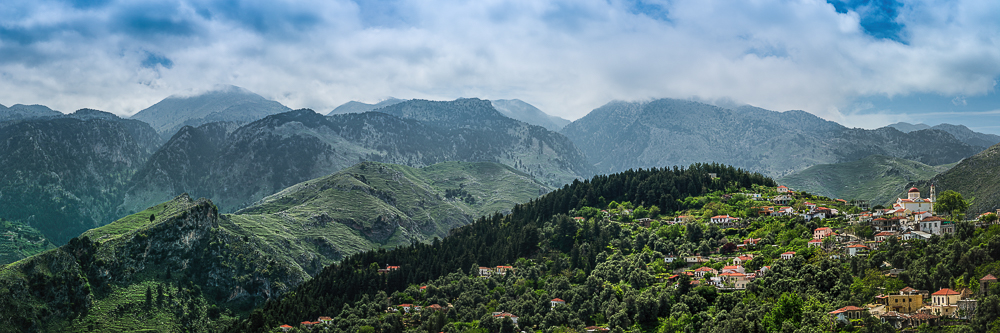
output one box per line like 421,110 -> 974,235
916,140 -> 1000,213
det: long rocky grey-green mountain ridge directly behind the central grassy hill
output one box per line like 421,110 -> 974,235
119,100 -> 590,215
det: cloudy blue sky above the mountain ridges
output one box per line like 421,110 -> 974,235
0,0 -> 1000,134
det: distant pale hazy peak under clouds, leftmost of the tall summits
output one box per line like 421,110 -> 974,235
132,86 -> 291,138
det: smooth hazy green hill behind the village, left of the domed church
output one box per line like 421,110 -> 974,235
778,155 -> 954,205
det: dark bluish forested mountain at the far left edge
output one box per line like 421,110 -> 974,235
0,109 -> 160,244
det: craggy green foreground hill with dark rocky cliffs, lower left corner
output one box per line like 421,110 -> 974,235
0,195 -> 308,332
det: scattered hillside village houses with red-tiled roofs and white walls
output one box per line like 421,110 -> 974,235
272,186 -> 1000,332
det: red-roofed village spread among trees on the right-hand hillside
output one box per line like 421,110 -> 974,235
281,180 -> 1000,332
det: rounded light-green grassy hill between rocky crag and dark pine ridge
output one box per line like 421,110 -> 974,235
231,162 -> 550,274
